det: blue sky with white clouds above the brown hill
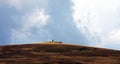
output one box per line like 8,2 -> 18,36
0,0 -> 120,50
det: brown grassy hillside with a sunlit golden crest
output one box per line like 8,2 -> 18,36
0,42 -> 120,64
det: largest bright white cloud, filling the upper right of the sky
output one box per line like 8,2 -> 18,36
72,0 -> 120,46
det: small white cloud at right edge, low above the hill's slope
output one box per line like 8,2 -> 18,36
104,29 -> 120,50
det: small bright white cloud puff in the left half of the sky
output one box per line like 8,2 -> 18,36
23,9 -> 50,29
